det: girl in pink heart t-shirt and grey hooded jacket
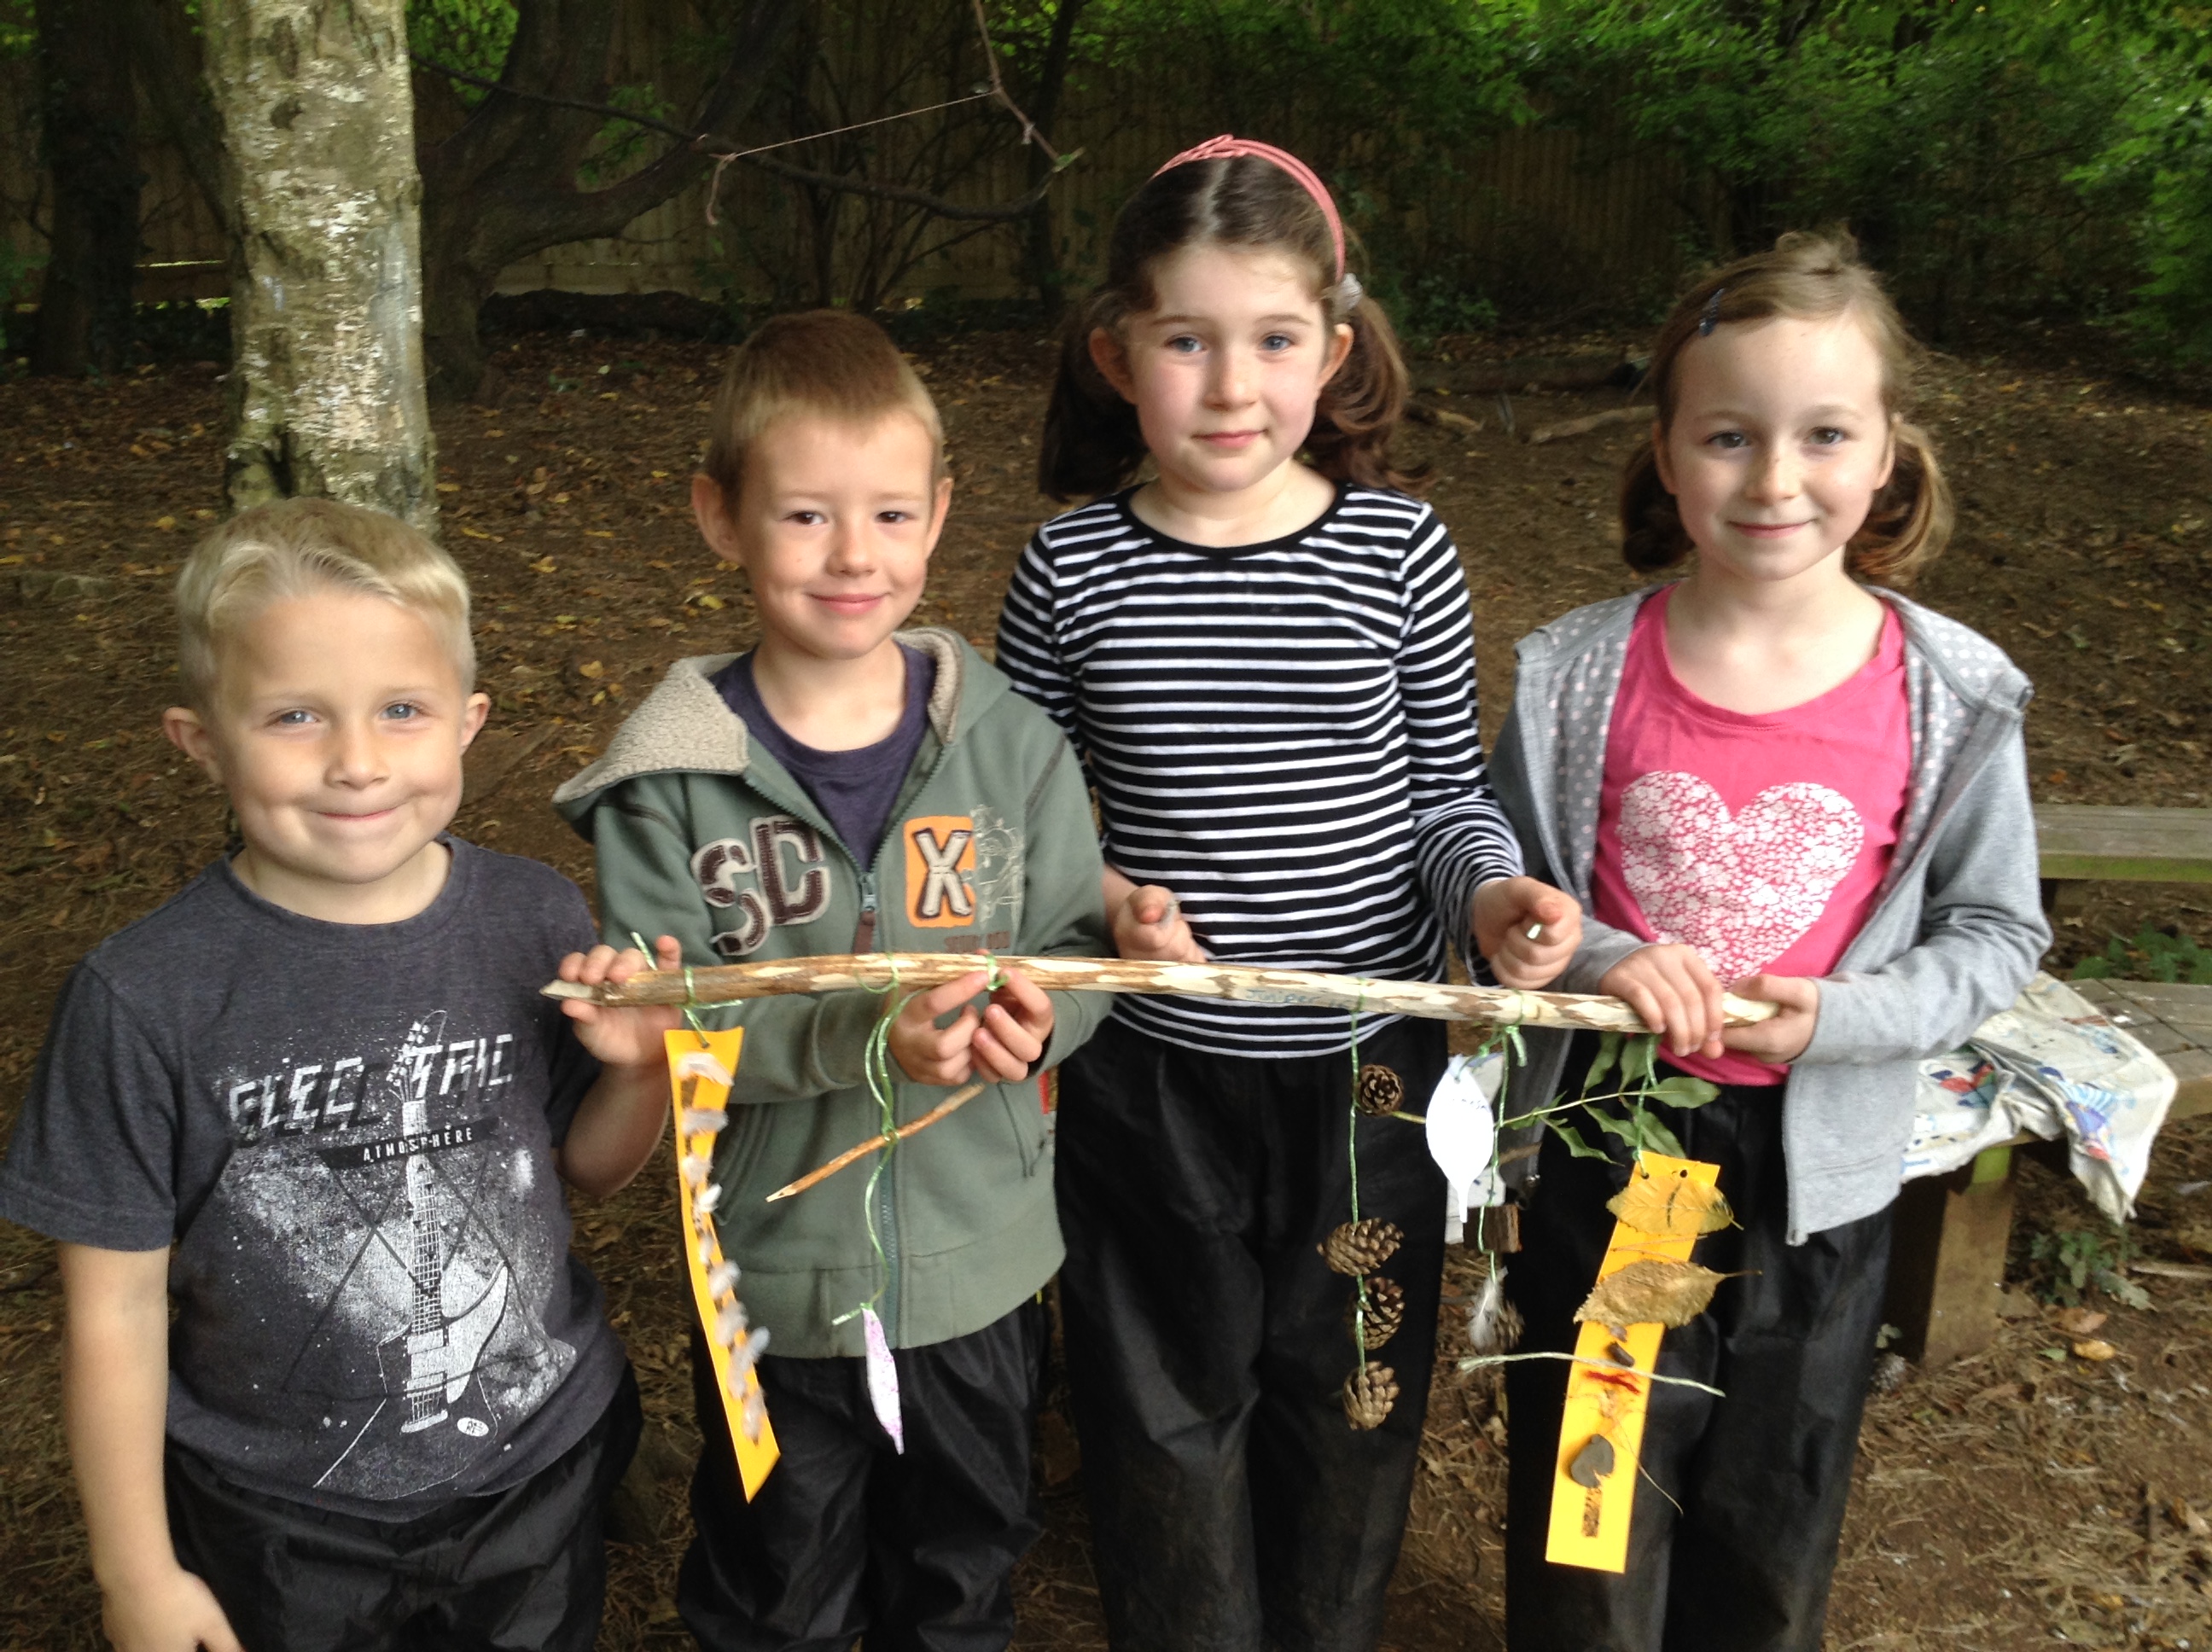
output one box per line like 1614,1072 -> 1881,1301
1493,235 -> 2051,1652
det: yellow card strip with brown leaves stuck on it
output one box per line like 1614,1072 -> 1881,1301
1544,1152 -> 1721,1573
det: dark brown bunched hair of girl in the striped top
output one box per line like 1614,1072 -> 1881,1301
1038,154 -> 1427,500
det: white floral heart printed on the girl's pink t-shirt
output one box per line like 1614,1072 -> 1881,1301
1621,770 -> 1867,982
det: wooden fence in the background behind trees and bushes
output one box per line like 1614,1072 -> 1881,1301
0,0 -> 1699,323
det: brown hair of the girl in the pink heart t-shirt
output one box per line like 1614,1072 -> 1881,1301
1619,230 -> 1951,586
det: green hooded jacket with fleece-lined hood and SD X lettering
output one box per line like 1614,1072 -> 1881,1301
553,628 -> 1109,1358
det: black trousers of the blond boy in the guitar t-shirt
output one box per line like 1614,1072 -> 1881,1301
164,1369 -> 642,1652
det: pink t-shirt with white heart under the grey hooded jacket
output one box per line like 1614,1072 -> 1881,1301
1591,590 -> 1911,1084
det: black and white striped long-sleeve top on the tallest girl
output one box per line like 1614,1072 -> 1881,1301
998,486 -> 1522,1057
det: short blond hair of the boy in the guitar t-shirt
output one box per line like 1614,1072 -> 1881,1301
177,500 -> 475,710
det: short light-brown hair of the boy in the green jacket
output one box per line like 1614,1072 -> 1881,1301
701,310 -> 945,511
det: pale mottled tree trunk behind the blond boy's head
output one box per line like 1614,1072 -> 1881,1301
201,0 -> 438,531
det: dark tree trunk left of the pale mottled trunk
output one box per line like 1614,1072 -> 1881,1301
31,0 -> 143,376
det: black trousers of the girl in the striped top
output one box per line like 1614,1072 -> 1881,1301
1057,1020 -> 1445,1652
